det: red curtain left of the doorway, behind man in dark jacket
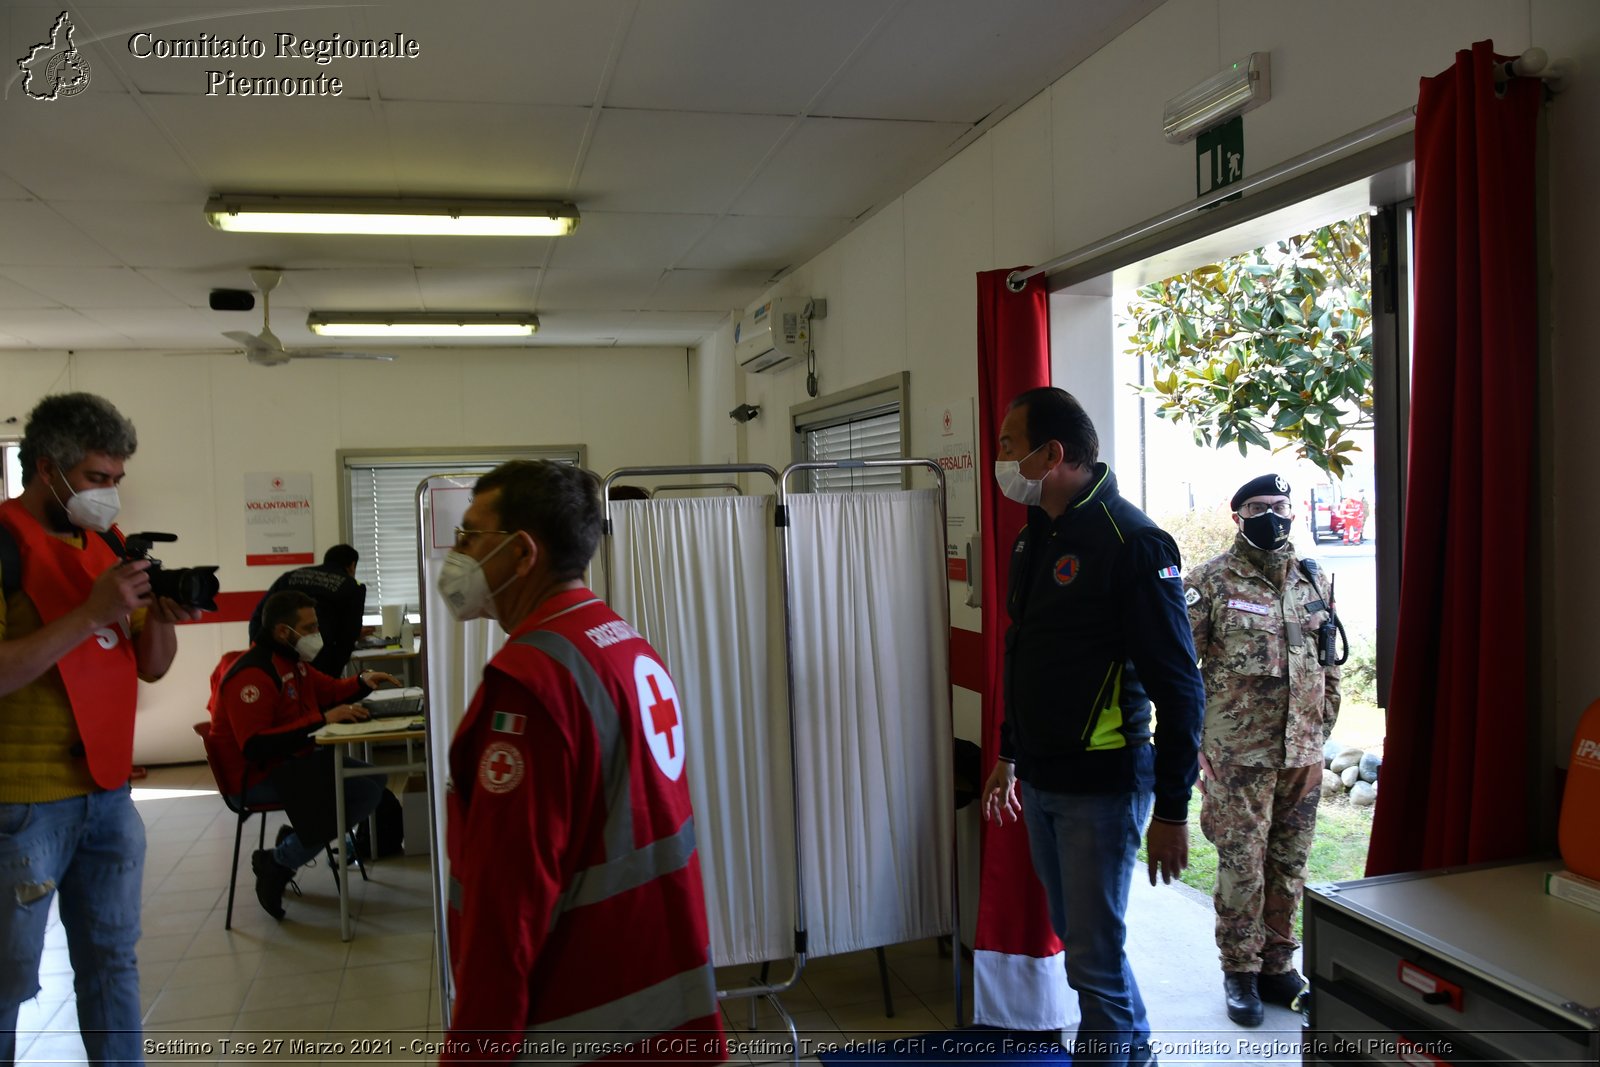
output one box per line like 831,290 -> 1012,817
974,267 -> 1066,1029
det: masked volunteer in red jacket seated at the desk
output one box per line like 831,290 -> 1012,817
211,592 -> 400,918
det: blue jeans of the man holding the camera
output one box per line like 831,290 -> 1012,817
0,785 -> 144,1064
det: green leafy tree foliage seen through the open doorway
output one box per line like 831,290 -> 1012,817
1126,216 -> 1373,478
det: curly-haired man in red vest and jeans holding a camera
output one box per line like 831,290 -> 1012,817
0,394 -> 200,1062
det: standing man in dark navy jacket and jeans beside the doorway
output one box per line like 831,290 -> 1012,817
984,389 -> 1205,1065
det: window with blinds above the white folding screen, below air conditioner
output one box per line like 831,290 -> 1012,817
790,374 -> 907,493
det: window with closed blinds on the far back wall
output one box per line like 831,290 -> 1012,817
342,450 -> 581,622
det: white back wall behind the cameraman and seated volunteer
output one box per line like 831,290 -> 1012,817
0,349 -> 698,763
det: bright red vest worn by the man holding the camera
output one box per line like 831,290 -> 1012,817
0,499 -> 139,789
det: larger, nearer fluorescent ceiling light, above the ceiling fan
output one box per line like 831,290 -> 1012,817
205,195 -> 578,237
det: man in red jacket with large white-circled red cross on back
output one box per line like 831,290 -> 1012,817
438,461 -> 725,1062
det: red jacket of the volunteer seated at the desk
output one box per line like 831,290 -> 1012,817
211,645 -> 368,793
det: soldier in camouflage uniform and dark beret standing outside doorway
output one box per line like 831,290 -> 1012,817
1184,475 -> 1339,1025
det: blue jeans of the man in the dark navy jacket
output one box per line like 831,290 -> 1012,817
1021,782 -> 1154,1064
